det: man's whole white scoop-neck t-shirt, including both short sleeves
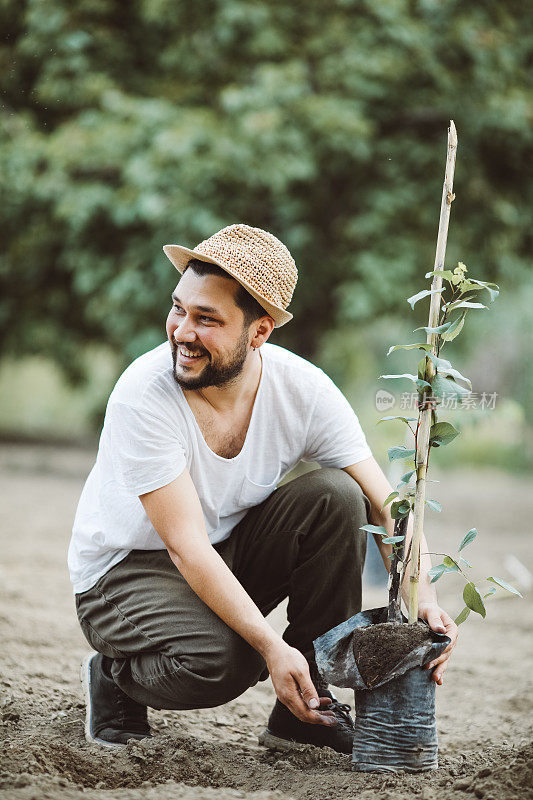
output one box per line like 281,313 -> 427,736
68,342 -> 372,592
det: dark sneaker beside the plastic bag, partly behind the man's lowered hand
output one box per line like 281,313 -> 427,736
259,692 -> 354,753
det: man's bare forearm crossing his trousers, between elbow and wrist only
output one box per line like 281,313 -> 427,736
169,542 -> 282,658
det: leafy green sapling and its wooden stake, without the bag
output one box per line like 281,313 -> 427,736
362,120 -> 521,624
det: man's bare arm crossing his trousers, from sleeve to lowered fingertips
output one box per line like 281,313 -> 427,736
140,470 -> 336,725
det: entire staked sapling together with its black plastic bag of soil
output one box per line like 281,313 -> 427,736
314,122 -> 518,772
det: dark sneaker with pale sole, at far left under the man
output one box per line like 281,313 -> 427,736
80,653 -> 150,747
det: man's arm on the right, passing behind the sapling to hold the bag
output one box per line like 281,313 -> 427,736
344,457 -> 458,685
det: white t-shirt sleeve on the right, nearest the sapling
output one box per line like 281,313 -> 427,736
302,372 -> 372,469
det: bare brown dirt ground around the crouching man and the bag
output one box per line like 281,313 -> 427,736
0,445 -> 533,800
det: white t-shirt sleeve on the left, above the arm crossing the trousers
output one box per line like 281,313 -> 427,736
103,402 -> 187,495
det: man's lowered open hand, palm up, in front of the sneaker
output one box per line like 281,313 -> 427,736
265,640 -> 337,726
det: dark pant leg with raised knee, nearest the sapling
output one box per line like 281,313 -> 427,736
232,469 -> 370,656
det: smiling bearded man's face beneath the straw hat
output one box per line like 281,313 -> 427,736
166,268 -> 250,389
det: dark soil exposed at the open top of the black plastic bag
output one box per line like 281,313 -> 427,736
352,622 -> 431,688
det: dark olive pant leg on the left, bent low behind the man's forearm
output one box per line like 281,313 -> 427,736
76,543 -> 265,710
